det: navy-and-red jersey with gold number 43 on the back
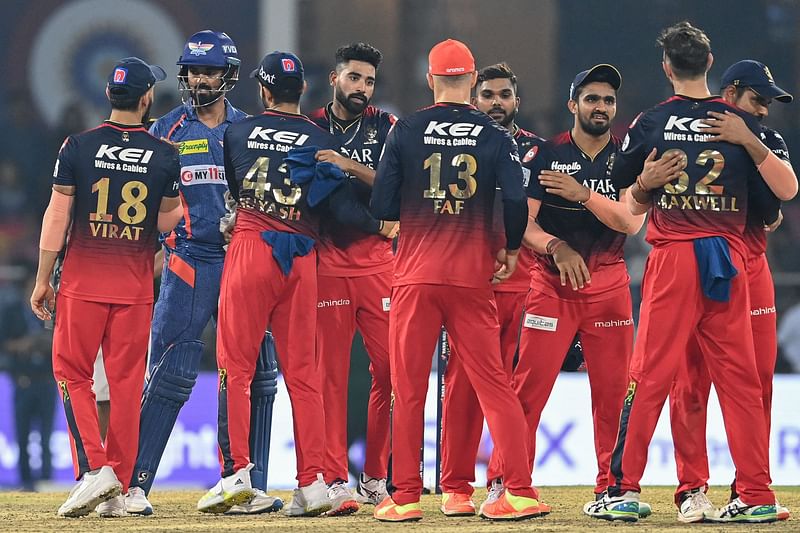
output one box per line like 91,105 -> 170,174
223,111 -> 339,239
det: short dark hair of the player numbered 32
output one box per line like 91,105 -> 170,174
656,20 -> 711,79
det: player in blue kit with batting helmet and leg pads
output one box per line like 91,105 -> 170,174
126,30 -> 283,515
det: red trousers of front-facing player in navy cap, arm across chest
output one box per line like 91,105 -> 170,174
487,285 -> 633,493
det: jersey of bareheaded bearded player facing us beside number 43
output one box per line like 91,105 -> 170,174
309,104 -> 397,276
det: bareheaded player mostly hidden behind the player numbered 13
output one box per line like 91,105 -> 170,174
441,63 -> 544,516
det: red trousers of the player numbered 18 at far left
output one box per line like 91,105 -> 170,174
53,294 -> 153,492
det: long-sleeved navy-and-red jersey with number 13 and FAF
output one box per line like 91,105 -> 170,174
372,103 -> 527,288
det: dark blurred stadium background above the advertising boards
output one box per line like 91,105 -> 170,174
0,0 -> 800,488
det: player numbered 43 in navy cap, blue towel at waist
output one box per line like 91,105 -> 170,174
202,52 -> 393,516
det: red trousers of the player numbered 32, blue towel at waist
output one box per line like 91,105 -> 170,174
609,241 -> 775,505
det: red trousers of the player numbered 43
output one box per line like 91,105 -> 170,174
217,231 -> 325,487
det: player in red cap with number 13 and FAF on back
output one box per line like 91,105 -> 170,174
372,39 -> 542,522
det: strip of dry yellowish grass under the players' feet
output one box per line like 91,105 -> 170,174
0,487 -> 800,533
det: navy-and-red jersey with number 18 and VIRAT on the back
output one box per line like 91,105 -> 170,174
53,121 -> 180,304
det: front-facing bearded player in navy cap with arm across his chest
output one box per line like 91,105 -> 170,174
487,64 -> 644,512
